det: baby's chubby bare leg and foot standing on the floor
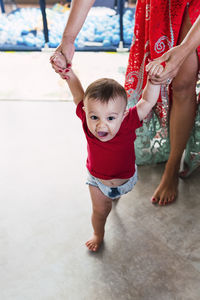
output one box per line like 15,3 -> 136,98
86,185 -> 112,252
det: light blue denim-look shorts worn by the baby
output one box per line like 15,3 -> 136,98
86,166 -> 137,200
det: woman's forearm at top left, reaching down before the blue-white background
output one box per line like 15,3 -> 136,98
62,0 -> 95,43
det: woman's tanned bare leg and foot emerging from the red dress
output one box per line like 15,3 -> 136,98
152,12 -> 199,205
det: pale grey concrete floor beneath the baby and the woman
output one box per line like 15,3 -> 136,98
0,53 -> 200,300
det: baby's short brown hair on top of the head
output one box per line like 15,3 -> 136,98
84,78 -> 127,104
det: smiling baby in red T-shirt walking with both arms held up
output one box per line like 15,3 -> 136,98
52,54 -> 160,251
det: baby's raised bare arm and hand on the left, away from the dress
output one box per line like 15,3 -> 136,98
54,54 -> 84,105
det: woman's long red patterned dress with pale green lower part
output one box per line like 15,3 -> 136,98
125,0 -> 200,168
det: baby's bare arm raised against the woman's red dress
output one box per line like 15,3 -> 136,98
136,78 -> 160,121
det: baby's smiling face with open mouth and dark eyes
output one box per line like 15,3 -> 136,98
84,97 -> 128,142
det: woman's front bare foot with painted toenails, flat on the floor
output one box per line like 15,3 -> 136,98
151,168 -> 178,206
